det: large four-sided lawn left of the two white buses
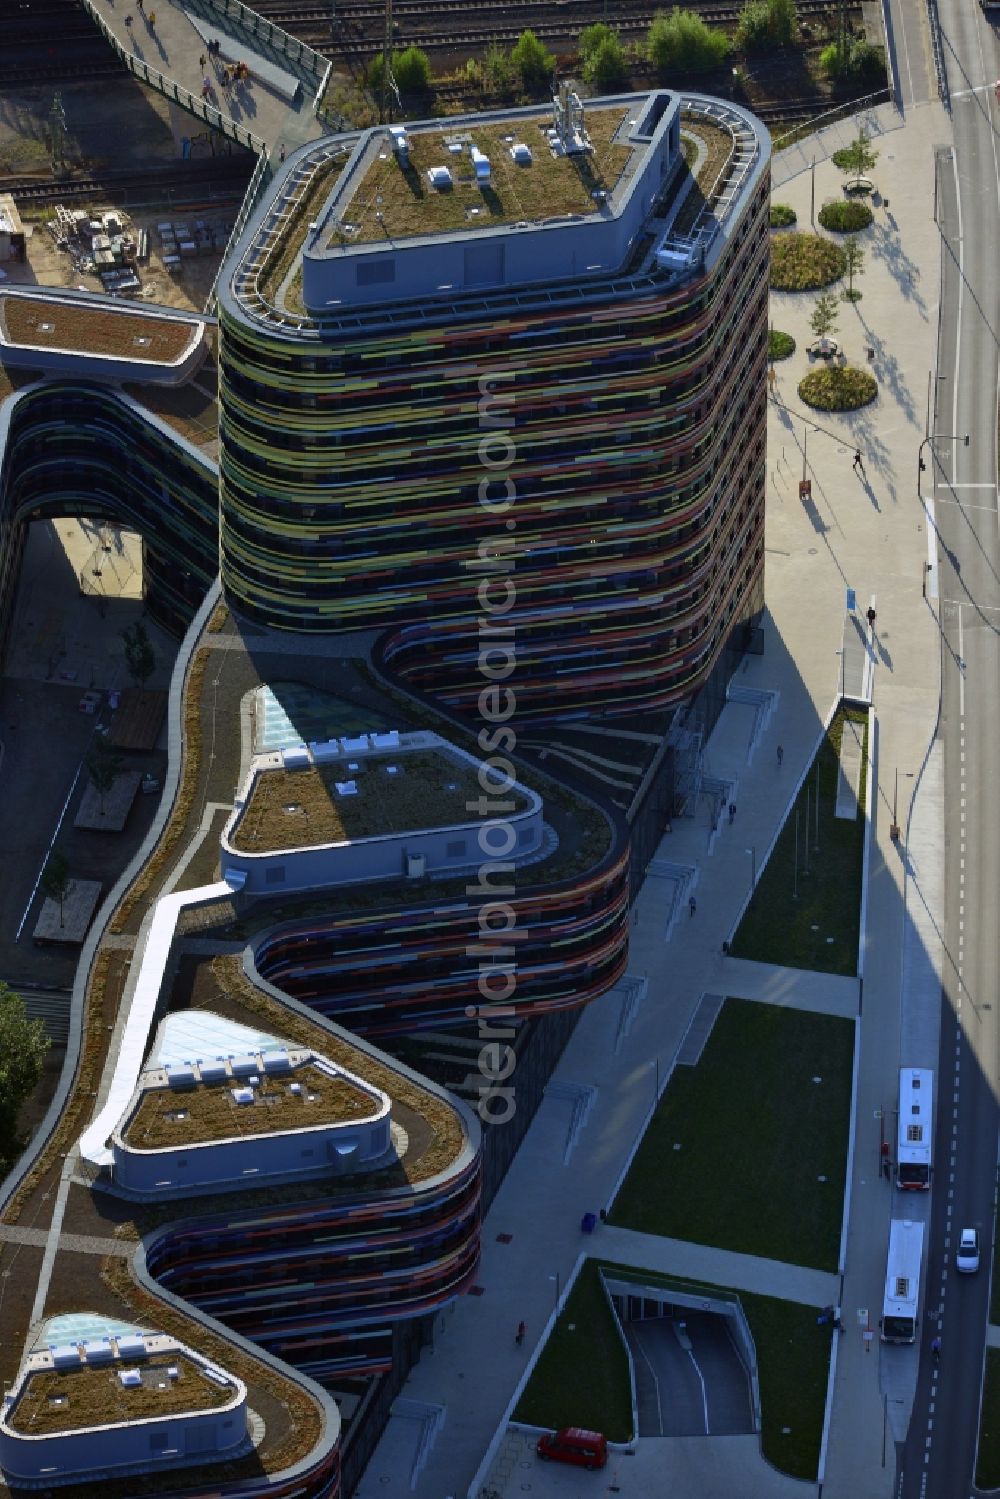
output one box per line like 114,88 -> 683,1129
610,1000 -> 855,1271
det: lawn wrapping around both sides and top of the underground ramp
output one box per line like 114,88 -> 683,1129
514,1261 -> 832,1483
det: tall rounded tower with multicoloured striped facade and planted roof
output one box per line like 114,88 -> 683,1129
219,90 -> 769,720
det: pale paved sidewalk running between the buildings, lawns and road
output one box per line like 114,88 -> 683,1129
358,106 -> 949,1499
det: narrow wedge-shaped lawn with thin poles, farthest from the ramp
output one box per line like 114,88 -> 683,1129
730,709 -> 868,977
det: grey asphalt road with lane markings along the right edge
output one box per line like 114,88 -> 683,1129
897,0 -> 1000,1499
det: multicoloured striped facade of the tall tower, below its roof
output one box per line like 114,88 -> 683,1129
220,95 -> 768,720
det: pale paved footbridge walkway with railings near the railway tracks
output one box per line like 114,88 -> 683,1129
82,0 -> 330,156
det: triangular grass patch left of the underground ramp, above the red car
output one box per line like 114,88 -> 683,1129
514,1259 -> 634,1442
